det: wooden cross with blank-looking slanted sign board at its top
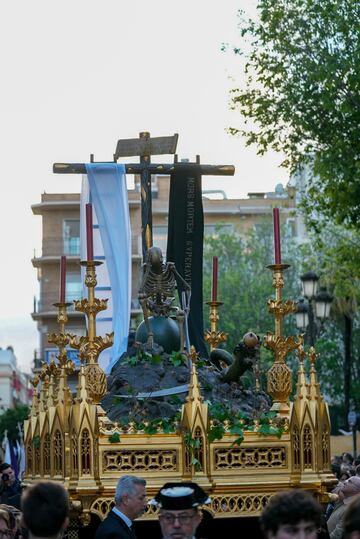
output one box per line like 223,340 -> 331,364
53,132 -> 235,260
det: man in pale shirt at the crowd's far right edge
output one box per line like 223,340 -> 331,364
327,475 -> 360,539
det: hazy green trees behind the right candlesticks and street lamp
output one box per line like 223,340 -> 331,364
204,225 -> 360,426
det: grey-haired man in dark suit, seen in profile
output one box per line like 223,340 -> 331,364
95,475 -> 146,539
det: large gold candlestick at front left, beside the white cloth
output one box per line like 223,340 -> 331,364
69,260 -> 114,404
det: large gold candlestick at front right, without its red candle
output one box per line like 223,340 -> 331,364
264,264 -> 301,415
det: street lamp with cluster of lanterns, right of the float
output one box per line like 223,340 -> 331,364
295,271 -> 333,346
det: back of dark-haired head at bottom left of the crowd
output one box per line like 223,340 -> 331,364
21,481 -> 69,538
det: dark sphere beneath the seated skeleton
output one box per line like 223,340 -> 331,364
135,316 -> 180,354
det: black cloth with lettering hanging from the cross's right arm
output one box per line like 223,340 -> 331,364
166,165 -> 208,357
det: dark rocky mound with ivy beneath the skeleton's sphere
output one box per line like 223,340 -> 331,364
102,345 -> 271,424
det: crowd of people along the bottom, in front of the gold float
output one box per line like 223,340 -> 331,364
0,460 -> 360,539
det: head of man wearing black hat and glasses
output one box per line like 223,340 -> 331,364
155,482 -> 209,539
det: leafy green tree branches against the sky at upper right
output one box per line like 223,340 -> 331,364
229,0 -> 360,229
